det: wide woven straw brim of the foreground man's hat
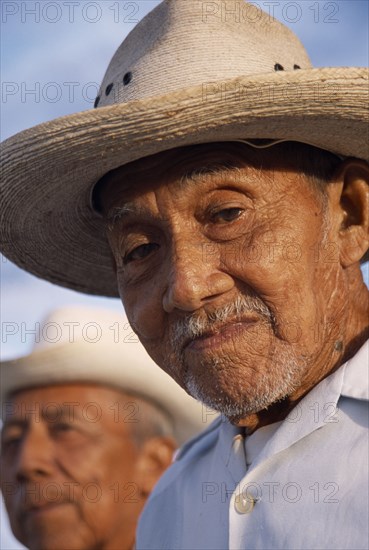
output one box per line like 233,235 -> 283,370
0,68 -> 369,296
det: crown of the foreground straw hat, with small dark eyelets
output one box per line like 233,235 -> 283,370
95,0 -> 311,107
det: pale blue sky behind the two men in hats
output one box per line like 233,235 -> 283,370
0,0 -> 369,550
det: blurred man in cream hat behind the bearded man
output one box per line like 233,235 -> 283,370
0,308 -> 211,550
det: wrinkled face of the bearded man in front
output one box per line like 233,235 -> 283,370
102,144 -> 343,421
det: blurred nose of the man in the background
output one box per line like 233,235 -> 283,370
14,429 -> 53,481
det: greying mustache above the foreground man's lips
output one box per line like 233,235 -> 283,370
171,295 -> 274,350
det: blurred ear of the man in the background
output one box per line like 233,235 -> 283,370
136,437 -> 177,496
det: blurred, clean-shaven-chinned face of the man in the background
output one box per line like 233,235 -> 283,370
1,384 -> 142,550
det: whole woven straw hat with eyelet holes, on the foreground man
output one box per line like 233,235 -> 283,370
0,0 -> 369,296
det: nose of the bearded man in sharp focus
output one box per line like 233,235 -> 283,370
163,239 -> 234,313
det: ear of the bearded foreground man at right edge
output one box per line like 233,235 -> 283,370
334,159 -> 369,267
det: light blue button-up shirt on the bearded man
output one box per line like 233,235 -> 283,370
137,342 -> 369,550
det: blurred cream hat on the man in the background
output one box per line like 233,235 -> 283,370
0,307 -> 216,445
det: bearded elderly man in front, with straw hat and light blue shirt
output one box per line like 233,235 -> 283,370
2,0 -> 369,550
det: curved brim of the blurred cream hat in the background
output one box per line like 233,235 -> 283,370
0,341 -> 211,445
